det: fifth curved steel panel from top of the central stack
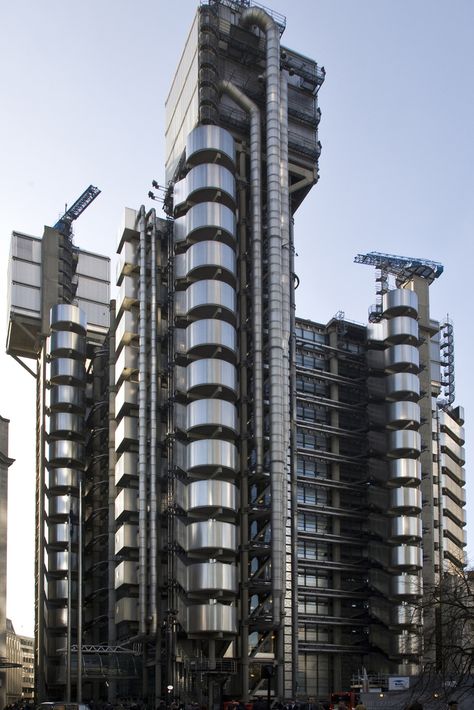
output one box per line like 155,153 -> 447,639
185,279 -> 237,323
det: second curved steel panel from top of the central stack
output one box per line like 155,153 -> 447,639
173,163 -> 236,210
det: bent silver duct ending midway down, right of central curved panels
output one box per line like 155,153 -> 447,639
219,81 -> 263,472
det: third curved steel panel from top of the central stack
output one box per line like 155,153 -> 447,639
173,202 -> 236,245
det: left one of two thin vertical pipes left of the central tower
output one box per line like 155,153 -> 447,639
138,205 -> 147,634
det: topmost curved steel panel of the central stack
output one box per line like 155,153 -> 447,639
186,124 -> 235,168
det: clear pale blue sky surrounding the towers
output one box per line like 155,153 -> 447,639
0,0 -> 474,634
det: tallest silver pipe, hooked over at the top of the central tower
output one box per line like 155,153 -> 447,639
240,7 -> 288,636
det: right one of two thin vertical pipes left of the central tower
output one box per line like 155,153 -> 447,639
149,210 -> 158,634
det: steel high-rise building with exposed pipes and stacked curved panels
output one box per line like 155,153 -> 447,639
9,0 -> 465,707
